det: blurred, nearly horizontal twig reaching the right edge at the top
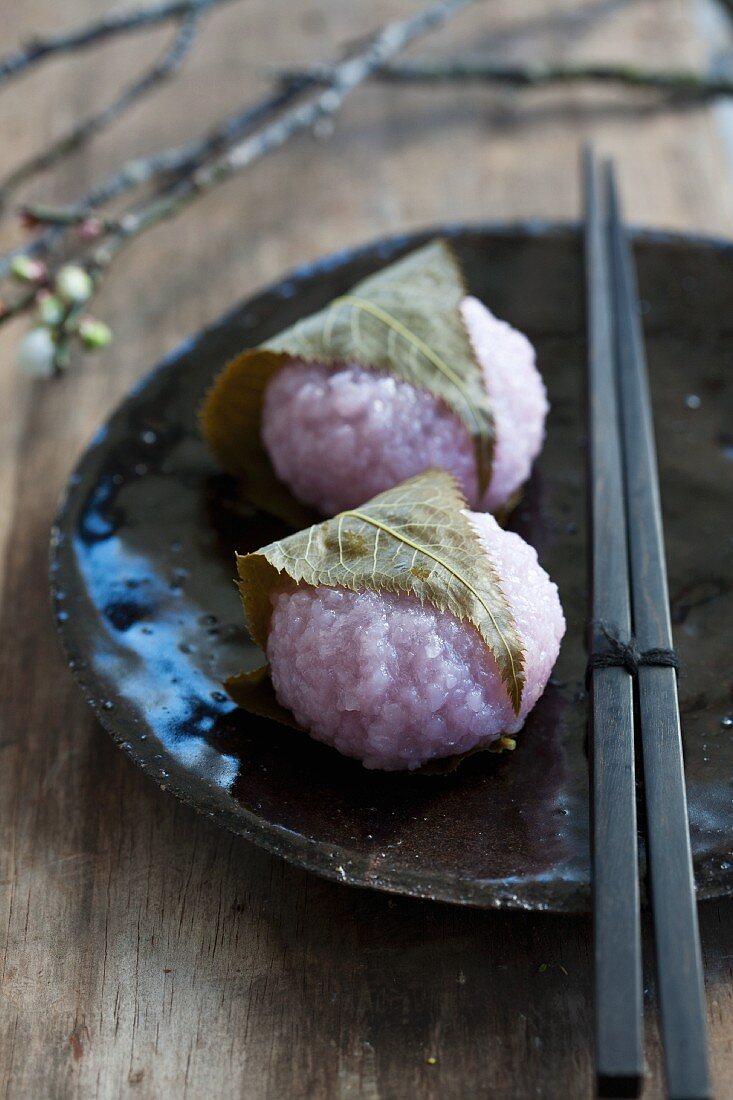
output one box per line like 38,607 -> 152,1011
276,58 -> 733,99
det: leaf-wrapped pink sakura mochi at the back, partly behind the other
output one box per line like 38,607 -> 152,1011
203,240 -> 548,526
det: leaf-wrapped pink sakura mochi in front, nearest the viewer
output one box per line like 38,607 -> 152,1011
225,472 -> 565,771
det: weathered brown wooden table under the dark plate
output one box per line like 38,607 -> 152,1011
0,0 -> 733,1100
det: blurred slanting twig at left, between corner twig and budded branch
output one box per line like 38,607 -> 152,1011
0,11 -> 199,207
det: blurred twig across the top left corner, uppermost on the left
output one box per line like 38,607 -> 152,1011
0,0 -> 231,83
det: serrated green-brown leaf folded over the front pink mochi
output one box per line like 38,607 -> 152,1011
231,470 -> 524,712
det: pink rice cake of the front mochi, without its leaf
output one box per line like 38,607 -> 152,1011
266,513 -> 565,771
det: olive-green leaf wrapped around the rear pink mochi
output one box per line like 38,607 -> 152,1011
201,240 -> 494,526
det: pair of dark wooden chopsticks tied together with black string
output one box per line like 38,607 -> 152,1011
583,151 -> 712,1100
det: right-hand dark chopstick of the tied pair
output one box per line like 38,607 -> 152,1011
606,165 -> 711,1100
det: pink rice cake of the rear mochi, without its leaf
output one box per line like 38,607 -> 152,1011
262,297 -> 548,516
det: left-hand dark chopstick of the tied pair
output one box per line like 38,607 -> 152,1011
583,151 -> 644,1096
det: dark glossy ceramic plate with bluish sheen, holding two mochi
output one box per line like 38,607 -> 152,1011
52,223 -> 733,911
